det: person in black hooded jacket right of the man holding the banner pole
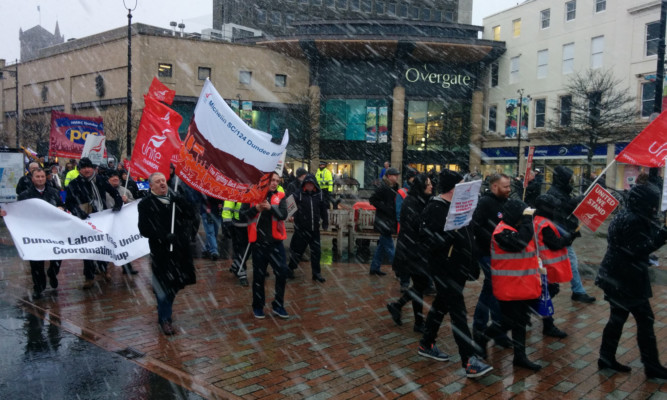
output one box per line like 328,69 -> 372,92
289,174 -> 329,283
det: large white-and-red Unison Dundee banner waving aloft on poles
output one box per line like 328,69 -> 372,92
175,80 -> 289,203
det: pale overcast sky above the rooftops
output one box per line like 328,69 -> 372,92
0,0 -> 523,63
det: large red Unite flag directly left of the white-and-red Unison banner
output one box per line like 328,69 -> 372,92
130,96 -> 183,178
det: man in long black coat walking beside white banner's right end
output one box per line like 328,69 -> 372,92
138,172 -> 198,336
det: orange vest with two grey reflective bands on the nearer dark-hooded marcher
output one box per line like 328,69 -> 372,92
491,221 -> 542,301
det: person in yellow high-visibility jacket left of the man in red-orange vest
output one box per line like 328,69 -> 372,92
222,200 -> 248,286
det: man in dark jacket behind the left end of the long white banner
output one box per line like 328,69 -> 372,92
13,167 -> 65,299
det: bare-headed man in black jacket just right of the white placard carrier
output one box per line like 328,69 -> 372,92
472,173 -> 512,348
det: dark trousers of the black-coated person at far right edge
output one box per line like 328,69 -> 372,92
600,297 -> 662,368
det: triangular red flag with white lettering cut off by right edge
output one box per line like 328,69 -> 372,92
616,112 -> 667,168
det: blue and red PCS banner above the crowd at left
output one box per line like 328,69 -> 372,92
49,111 -> 104,158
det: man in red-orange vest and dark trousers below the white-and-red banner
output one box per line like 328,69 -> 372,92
241,172 -> 289,319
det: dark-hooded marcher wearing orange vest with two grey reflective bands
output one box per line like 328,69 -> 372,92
478,199 -> 542,371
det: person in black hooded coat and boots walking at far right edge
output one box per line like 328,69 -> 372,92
595,185 -> 667,379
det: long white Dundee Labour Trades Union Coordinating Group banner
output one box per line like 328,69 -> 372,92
2,199 -> 150,265
